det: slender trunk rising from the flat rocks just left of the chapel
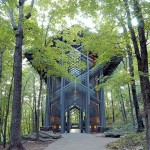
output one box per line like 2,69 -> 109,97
36,71 -> 43,140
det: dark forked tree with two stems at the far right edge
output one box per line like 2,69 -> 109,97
124,0 -> 150,149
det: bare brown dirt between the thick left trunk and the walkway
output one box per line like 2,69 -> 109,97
0,141 -> 56,150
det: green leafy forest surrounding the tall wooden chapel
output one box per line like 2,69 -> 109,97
0,0 -> 150,150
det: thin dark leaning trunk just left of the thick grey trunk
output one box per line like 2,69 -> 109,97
3,77 -> 13,148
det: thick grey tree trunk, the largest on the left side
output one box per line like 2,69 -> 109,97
8,0 -> 25,150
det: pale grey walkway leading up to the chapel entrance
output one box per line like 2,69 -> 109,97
45,133 -> 117,150
